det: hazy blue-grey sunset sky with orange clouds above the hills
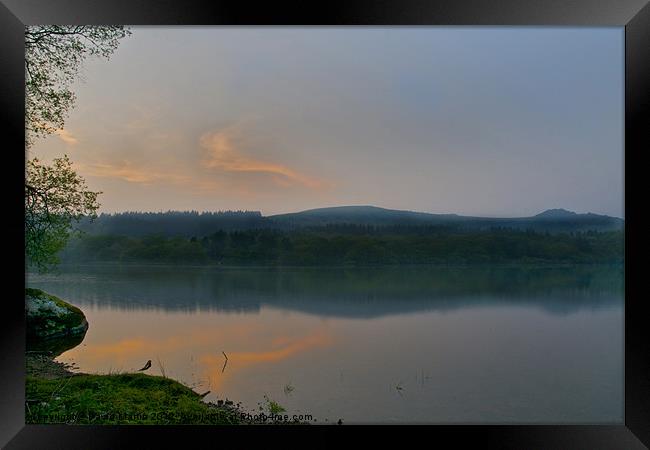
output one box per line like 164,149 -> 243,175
30,27 -> 624,217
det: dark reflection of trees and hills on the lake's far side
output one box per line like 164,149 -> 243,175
28,266 -> 624,317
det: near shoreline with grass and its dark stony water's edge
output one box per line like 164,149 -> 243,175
25,291 -> 301,425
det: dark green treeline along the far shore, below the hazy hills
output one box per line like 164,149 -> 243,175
61,227 -> 624,266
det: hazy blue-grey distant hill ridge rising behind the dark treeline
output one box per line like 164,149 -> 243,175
79,205 -> 625,237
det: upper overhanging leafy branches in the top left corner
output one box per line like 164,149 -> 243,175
25,25 -> 131,148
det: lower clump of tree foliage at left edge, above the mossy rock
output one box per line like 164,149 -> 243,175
25,155 -> 101,271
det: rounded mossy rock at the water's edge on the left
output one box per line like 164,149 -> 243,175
25,288 -> 88,341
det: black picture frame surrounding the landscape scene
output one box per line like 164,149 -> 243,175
0,0 -> 650,449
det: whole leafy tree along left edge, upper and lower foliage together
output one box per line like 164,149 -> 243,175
25,25 -> 131,271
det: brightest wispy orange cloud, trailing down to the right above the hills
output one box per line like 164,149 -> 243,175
200,129 -> 327,189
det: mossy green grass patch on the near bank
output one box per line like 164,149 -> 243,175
25,373 -> 243,425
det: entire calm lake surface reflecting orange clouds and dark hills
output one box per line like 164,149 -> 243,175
27,266 -> 624,424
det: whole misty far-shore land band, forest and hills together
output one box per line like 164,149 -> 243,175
61,207 -> 623,266
